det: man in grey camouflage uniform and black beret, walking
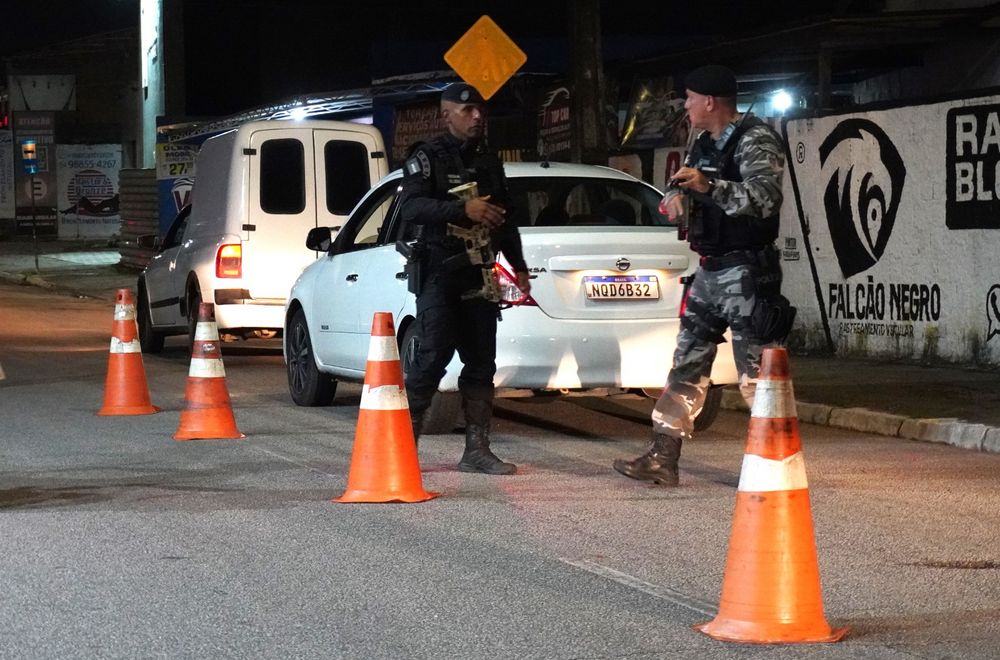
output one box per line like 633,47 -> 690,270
614,65 -> 794,486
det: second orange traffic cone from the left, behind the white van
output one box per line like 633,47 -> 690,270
174,303 -> 246,440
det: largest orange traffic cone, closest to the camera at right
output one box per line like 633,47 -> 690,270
695,348 -> 847,644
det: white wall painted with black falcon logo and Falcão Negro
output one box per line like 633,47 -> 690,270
778,94 -> 1000,365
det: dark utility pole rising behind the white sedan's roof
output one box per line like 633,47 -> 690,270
567,0 -> 608,165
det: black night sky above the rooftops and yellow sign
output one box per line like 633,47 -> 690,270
7,0 -> 879,115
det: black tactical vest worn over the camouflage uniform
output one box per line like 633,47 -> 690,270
688,117 -> 779,256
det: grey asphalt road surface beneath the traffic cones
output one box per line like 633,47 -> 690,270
0,284 -> 1000,658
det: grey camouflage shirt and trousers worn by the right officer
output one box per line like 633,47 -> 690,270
652,124 -> 784,438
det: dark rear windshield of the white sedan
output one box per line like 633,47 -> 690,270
508,177 -> 670,227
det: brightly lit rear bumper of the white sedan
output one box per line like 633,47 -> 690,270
440,307 -> 738,391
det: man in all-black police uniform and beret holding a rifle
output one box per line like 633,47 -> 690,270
400,83 -> 531,474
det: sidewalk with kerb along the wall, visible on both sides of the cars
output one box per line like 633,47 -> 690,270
0,238 -> 1000,453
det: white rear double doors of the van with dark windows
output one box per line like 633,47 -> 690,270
241,124 -> 386,304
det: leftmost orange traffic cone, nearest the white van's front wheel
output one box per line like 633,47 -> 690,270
97,289 -> 160,415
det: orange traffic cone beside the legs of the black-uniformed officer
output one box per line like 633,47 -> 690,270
333,312 -> 440,502
